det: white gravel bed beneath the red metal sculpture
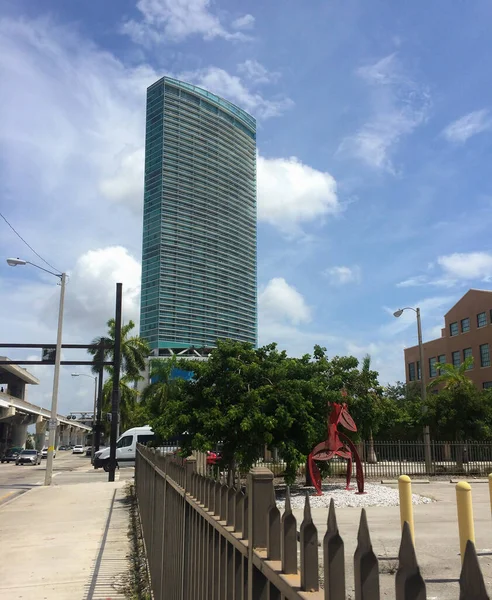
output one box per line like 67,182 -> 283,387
277,483 -> 433,510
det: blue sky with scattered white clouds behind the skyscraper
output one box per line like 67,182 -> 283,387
0,0 -> 492,410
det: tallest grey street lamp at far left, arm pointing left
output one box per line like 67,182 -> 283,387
7,258 -> 67,485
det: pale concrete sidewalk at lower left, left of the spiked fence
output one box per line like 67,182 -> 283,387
0,482 -> 130,600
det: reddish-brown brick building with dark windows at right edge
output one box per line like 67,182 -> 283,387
405,290 -> 492,389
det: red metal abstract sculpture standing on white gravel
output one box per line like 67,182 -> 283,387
308,393 -> 364,496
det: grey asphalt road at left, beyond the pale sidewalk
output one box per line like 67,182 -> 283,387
0,451 -> 134,506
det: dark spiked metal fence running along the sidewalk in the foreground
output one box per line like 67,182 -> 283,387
135,446 -> 488,600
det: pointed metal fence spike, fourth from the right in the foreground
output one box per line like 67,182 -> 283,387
323,498 -> 345,600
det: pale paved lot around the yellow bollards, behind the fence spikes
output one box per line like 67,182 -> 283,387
293,480 -> 492,600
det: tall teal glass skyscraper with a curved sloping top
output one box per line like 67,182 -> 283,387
140,77 -> 257,355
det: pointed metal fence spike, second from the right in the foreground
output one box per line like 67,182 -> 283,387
395,521 -> 427,600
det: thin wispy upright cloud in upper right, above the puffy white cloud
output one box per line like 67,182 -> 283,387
338,54 -> 430,172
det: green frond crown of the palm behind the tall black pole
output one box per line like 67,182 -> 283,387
89,319 -> 150,381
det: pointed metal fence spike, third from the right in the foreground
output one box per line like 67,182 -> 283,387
354,508 -> 379,600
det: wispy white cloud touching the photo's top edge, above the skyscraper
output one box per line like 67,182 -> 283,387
122,0 -> 251,46
